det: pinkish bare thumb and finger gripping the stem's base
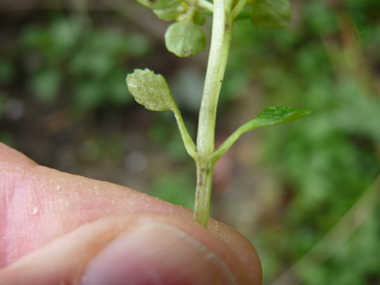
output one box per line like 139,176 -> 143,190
0,143 -> 262,285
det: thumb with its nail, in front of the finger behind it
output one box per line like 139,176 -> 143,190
0,213 -> 261,285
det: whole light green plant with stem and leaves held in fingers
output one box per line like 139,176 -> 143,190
127,0 -> 310,227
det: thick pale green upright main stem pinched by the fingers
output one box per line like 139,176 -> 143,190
194,0 -> 232,227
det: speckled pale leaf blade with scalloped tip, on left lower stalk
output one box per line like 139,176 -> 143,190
127,69 -> 177,112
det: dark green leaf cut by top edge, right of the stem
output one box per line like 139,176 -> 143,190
248,0 -> 292,29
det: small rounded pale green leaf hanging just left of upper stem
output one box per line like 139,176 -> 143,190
165,20 -> 206,57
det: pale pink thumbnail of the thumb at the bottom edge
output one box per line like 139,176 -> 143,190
81,222 -> 238,285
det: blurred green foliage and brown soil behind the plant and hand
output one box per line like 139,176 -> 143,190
0,0 -> 380,285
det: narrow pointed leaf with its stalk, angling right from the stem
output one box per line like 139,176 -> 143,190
211,107 -> 310,162
